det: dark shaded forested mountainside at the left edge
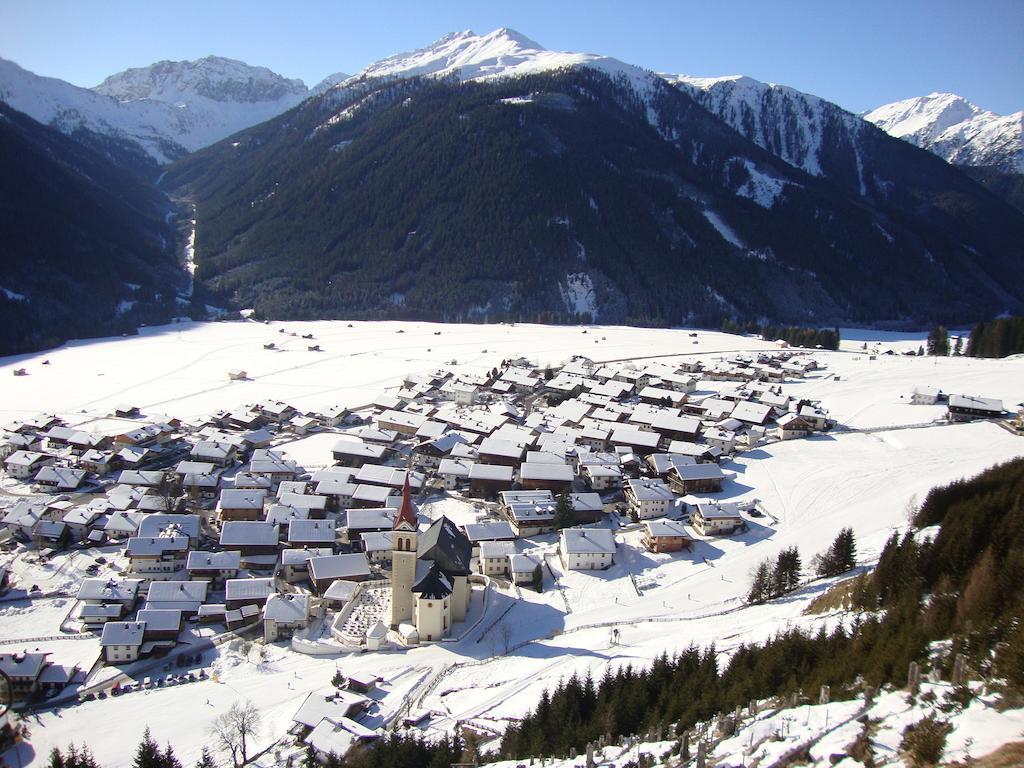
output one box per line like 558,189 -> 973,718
0,103 -> 187,354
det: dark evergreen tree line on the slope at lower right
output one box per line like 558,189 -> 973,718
501,459 -> 1024,758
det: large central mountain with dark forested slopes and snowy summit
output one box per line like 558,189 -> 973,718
165,30 -> 1024,325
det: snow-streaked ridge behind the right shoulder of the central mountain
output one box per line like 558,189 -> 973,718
662,75 -> 866,182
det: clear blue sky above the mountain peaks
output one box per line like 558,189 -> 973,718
0,0 -> 1024,114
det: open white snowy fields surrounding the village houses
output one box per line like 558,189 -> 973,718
0,322 -> 1024,765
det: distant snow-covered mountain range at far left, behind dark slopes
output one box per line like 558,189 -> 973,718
0,56 -> 326,165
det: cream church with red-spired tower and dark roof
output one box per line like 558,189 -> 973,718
391,473 -> 473,644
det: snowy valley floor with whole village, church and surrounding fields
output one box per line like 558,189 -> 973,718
0,322 -> 1024,766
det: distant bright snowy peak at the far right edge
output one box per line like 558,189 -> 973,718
864,93 -> 1024,173
